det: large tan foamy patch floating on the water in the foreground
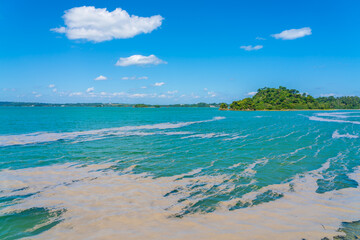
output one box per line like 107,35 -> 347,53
0,164 -> 360,240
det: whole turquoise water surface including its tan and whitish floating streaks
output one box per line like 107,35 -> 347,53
0,107 -> 360,239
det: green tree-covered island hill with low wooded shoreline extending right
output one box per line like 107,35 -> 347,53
226,87 -> 360,111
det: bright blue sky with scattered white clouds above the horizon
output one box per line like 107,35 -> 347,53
0,0 -> 360,104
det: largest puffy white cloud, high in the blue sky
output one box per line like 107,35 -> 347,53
51,6 -> 163,42
